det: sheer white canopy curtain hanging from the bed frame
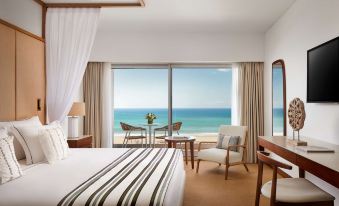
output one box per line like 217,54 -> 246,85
46,8 -> 100,122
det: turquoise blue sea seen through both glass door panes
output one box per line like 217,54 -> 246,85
114,108 -> 231,134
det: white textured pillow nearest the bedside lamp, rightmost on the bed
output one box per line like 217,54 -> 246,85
40,124 -> 69,164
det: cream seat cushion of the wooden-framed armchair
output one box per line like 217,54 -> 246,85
198,148 -> 242,164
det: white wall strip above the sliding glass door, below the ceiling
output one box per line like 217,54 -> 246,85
90,30 -> 264,63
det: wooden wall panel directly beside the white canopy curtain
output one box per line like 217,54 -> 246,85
16,31 -> 45,123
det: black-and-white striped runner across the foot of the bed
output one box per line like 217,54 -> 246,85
58,148 -> 181,206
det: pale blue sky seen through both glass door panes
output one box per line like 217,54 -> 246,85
113,68 -> 232,108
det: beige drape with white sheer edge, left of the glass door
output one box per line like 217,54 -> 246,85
83,62 -> 112,147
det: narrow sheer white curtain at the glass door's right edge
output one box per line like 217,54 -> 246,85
231,63 -> 243,125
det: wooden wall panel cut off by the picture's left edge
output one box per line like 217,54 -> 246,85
0,24 -> 15,121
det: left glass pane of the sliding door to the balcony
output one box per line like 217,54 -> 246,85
114,67 -> 168,144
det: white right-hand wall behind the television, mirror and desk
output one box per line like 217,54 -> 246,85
265,0 -> 339,205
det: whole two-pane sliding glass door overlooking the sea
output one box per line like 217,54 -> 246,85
113,65 -> 232,144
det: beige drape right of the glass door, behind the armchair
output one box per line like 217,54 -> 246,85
239,62 -> 264,163
